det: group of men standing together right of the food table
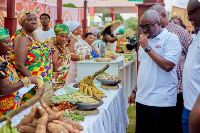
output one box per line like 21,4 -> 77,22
128,0 -> 200,133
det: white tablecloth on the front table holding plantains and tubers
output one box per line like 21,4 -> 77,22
0,84 -> 128,133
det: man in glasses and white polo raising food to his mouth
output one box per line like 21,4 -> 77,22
128,10 -> 182,133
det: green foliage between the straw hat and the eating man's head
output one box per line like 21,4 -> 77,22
123,17 -> 138,33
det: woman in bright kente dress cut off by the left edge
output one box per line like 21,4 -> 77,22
0,27 -> 37,117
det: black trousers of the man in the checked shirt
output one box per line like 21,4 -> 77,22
176,92 -> 183,133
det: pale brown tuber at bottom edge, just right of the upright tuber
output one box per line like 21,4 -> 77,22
47,122 -> 69,133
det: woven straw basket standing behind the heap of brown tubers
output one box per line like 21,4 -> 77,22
40,82 -> 55,105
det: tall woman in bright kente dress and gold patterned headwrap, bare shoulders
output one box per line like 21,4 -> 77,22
10,11 -> 53,102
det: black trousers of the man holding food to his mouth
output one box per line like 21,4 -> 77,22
136,103 -> 177,133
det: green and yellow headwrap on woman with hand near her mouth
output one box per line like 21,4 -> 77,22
54,23 -> 69,35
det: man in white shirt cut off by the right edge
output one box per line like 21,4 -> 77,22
182,0 -> 200,133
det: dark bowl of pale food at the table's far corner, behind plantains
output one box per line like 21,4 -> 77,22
96,74 -> 121,86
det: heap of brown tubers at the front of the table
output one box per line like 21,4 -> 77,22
13,104 -> 83,133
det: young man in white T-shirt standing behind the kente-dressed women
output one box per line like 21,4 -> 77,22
35,13 -> 56,42
